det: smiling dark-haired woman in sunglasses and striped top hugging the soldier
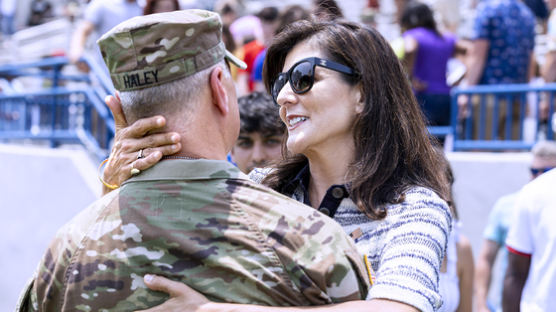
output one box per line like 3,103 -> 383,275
103,21 -> 451,311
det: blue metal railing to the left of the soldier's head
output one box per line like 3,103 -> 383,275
0,57 -> 115,158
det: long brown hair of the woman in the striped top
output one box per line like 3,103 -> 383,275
263,21 -> 447,220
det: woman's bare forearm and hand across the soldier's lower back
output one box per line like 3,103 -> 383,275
137,275 -> 418,312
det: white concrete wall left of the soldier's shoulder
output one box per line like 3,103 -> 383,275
0,144 -> 101,311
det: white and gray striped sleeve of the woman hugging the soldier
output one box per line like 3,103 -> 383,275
367,188 -> 451,312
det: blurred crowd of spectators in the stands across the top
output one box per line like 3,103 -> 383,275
1,0 -> 556,138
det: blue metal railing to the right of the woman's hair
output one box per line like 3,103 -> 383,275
450,83 -> 556,151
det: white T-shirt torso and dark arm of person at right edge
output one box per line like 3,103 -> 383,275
502,165 -> 556,312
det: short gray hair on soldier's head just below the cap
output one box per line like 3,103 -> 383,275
120,61 -> 230,124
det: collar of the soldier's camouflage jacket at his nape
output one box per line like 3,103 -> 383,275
124,159 -> 249,184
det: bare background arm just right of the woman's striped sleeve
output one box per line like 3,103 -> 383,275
456,235 -> 475,312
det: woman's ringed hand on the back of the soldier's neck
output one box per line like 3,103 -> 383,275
102,94 -> 181,194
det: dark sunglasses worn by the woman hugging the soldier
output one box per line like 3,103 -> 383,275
271,57 -> 355,104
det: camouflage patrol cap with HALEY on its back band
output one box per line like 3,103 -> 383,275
97,10 -> 247,91
